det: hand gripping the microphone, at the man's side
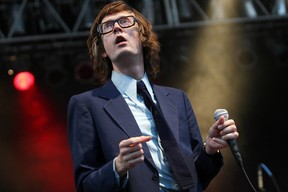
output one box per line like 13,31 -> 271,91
205,115 -> 239,155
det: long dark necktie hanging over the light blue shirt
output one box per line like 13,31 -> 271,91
137,81 -> 193,189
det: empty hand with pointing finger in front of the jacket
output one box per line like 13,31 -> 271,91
115,136 -> 152,177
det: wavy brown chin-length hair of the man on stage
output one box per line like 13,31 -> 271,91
87,1 -> 160,85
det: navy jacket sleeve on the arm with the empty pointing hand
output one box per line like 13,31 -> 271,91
67,95 -> 117,192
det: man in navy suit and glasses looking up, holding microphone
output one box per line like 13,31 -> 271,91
68,1 -> 239,192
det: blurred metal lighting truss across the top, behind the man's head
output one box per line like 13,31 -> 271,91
0,0 -> 287,40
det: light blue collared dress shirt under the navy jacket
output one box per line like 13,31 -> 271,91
111,71 -> 179,190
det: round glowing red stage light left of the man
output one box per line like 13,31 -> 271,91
14,71 -> 35,91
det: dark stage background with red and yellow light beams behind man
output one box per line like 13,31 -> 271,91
0,0 -> 288,192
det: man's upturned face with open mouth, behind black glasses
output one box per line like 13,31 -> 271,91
102,11 -> 142,63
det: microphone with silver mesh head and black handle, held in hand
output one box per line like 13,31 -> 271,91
214,109 -> 244,168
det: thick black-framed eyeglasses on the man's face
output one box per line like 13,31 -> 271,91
97,16 -> 138,35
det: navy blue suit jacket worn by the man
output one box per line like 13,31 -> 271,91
68,80 -> 223,192
